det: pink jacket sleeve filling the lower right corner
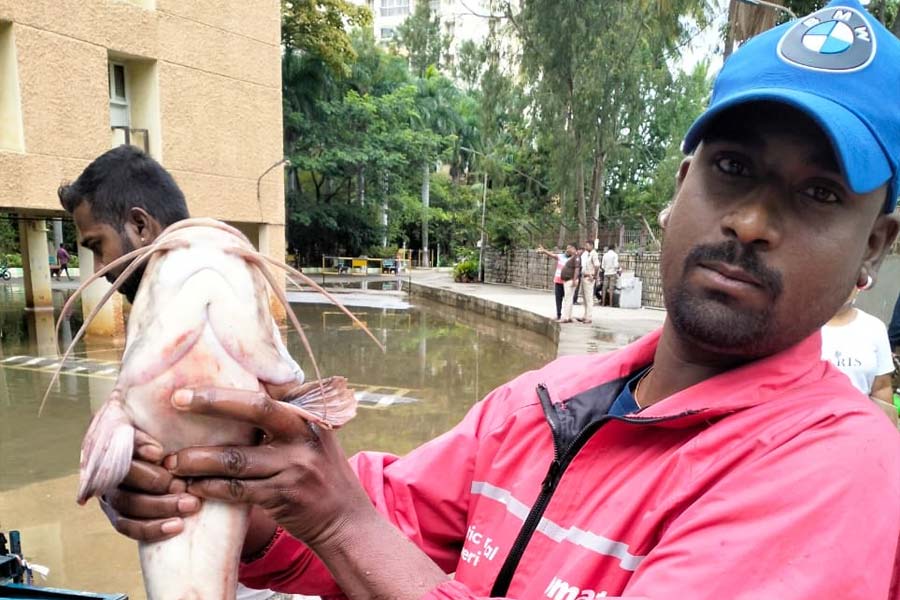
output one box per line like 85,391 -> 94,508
418,415 -> 900,600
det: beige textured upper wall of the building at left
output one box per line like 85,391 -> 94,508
0,0 -> 284,234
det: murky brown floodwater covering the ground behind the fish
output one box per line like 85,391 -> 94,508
0,284 -> 556,599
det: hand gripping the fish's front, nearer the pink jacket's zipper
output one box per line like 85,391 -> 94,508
163,387 -> 378,548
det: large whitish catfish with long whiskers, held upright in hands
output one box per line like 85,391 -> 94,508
42,219 -> 377,600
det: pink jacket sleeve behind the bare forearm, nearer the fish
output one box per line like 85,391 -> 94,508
240,387 -> 507,596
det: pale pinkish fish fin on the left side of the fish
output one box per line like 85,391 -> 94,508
78,390 -> 134,504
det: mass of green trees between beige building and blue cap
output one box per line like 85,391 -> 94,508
282,0 -> 716,264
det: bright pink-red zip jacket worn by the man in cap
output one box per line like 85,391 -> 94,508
241,332 -> 900,600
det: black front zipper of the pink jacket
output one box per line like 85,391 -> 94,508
491,383 -> 688,598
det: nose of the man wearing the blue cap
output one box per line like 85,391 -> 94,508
722,186 -> 788,249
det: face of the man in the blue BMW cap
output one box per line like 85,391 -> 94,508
662,105 -> 897,358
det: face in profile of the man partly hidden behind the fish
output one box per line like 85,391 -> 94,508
72,201 -> 144,302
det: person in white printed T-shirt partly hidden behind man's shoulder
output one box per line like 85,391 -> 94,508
822,289 -> 897,423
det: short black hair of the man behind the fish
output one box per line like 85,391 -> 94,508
57,144 -> 190,230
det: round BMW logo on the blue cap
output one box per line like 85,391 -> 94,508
778,6 -> 875,73
